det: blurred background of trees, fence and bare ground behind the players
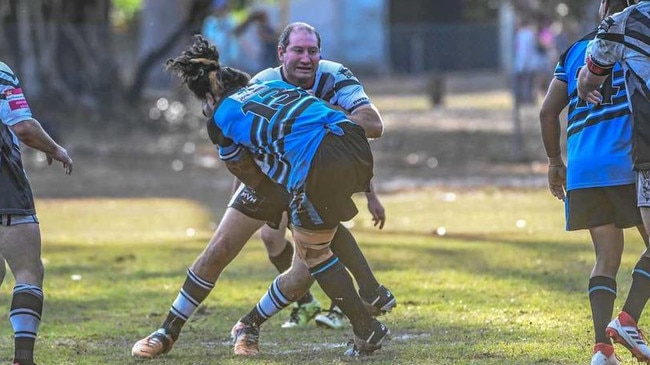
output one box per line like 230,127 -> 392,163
0,0 -> 600,208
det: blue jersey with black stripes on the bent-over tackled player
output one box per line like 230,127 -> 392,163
213,81 -> 351,191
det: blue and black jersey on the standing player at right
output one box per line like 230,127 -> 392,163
555,32 -> 635,190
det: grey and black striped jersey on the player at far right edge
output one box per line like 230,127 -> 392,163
587,0 -> 650,170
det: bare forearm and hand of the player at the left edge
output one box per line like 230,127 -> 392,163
10,118 -> 72,175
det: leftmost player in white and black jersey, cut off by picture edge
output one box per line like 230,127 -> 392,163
0,62 -> 72,365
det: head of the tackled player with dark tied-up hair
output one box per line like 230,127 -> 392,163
165,34 -> 251,99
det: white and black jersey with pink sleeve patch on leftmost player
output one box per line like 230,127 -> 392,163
0,62 -> 35,215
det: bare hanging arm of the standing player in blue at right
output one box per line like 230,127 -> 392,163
539,78 -> 569,200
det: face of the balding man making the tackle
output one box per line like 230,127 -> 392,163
278,29 -> 320,88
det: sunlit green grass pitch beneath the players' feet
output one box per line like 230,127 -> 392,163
0,188 -> 643,365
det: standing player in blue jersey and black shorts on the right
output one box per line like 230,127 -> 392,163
540,0 -> 648,365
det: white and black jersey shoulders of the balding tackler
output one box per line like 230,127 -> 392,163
251,60 -> 370,113
